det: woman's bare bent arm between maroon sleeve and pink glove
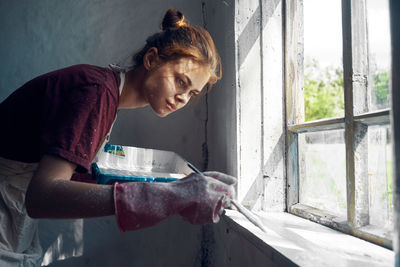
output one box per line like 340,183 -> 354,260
25,155 -> 114,218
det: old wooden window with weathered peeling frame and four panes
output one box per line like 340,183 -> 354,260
284,0 -> 393,248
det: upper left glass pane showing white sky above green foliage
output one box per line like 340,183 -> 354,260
304,0 -> 344,121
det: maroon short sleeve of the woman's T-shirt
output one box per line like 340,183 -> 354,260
41,84 -> 117,171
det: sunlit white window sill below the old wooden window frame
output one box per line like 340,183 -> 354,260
226,210 -> 394,267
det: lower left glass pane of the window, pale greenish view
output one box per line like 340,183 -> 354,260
299,130 -> 347,218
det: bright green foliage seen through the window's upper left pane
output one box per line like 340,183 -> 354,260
304,60 -> 344,121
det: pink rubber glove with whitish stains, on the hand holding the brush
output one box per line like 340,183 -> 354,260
114,172 -> 236,231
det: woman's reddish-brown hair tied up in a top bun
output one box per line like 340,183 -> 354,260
133,9 -> 222,91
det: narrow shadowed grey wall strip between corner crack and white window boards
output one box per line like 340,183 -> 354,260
204,0 -> 237,176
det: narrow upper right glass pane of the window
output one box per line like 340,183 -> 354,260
367,0 -> 391,111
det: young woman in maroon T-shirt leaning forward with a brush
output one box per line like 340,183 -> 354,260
0,9 -> 235,266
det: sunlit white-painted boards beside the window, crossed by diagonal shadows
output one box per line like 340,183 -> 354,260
217,0 -> 286,211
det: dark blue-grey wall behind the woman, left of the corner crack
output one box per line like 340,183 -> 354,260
0,0 -> 209,266
